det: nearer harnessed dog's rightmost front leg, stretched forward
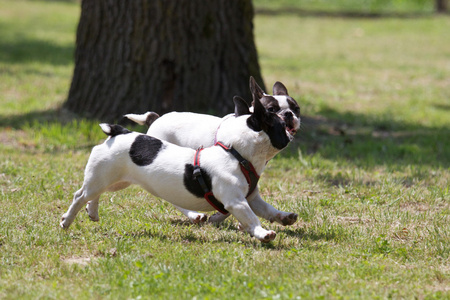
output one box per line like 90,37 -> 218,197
244,190 -> 298,226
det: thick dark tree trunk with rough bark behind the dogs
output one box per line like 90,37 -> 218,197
65,0 -> 262,121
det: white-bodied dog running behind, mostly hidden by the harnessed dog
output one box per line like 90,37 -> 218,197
125,77 -> 300,223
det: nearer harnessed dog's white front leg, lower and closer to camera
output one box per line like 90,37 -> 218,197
224,197 -> 277,243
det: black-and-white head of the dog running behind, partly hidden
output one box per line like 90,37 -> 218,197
250,77 -> 300,135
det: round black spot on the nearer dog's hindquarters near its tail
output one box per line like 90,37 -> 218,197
130,135 -> 163,167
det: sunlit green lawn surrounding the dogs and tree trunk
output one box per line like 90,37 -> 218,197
0,0 -> 450,299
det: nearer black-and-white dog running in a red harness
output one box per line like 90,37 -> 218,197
60,97 -> 298,242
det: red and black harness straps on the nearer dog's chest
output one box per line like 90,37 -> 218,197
193,142 -> 259,215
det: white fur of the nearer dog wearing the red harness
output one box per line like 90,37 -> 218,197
60,115 -> 297,242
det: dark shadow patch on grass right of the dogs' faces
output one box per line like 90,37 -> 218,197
279,109 -> 450,169
